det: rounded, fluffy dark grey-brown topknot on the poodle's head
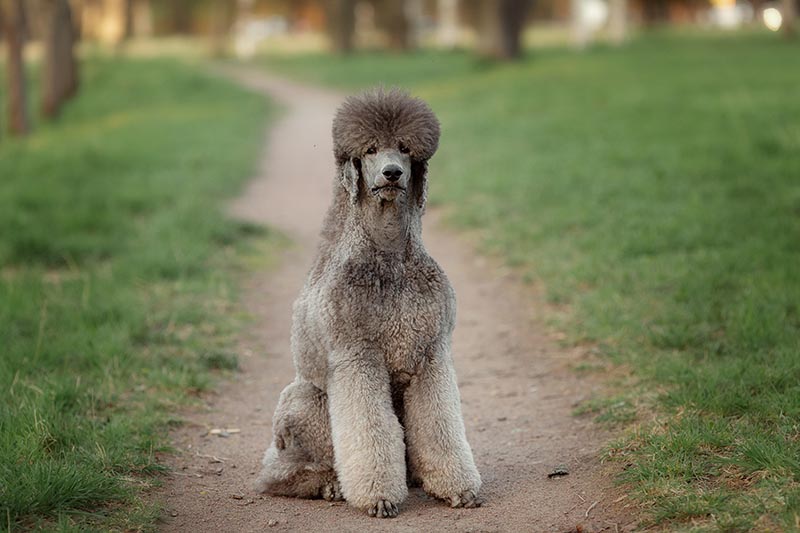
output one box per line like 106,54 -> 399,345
333,87 -> 439,165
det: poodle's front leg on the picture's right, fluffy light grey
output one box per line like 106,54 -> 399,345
403,343 -> 481,507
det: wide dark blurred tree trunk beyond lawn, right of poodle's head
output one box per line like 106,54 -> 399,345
479,0 -> 530,60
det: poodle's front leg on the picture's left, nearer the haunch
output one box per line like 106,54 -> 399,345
328,352 -> 408,518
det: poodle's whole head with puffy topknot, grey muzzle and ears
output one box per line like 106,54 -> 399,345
333,88 -> 439,208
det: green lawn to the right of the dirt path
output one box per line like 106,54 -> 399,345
264,34 -> 800,531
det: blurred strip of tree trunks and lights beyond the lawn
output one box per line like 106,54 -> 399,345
2,0 -> 798,133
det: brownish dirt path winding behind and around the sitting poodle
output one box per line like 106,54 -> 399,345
161,66 -> 630,532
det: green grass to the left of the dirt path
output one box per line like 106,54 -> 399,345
0,58 -> 275,530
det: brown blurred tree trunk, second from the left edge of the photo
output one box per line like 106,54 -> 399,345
42,0 -> 78,117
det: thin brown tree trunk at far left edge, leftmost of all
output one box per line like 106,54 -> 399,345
0,0 -> 30,135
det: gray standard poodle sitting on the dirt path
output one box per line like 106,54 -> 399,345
257,89 -> 481,518
